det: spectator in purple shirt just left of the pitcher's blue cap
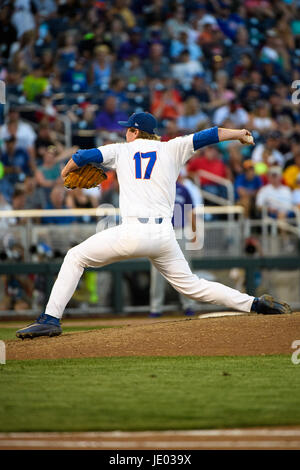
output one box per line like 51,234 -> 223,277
95,95 -> 128,132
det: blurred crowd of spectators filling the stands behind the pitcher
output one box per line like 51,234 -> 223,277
0,0 -> 300,310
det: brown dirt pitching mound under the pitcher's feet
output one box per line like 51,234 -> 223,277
6,313 -> 300,359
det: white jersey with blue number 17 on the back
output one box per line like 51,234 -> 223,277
99,134 -> 194,217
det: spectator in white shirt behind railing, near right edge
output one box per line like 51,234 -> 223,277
256,166 -> 294,219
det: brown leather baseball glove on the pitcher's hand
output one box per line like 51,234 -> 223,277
64,163 -> 107,189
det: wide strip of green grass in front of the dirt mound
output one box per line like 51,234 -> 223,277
0,356 -> 300,431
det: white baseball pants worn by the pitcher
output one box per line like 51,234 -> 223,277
45,217 -> 254,318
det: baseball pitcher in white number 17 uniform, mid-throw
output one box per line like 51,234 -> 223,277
17,112 -> 291,339
